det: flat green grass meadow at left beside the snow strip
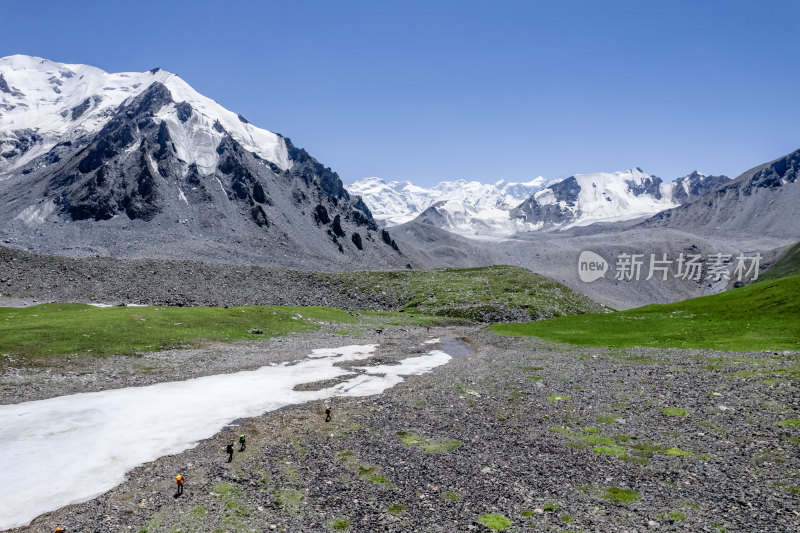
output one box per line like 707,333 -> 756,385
0,304 -> 358,359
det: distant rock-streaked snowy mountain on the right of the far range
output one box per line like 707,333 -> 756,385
510,167 -> 729,229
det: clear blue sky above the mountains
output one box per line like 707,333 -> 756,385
0,0 -> 800,184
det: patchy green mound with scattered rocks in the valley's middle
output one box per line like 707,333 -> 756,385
334,265 -> 603,322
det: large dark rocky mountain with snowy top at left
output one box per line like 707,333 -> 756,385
0,55 -> 397,265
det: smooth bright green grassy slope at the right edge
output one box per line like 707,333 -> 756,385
491,276 -> 800,350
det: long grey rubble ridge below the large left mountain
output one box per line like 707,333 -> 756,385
0,246 -> 402,311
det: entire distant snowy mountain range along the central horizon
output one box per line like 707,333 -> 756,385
347,168 -> 730,237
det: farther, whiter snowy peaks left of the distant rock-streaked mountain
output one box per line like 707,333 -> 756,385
346,177 -> 550,235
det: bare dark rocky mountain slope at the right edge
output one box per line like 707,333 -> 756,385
644,145 -> 800,238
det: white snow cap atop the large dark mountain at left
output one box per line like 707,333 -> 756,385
0,55 -> 290,174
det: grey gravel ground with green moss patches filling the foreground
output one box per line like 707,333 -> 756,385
3,327 -> 800,533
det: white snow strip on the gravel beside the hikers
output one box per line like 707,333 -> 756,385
0,344 -> 450,529
